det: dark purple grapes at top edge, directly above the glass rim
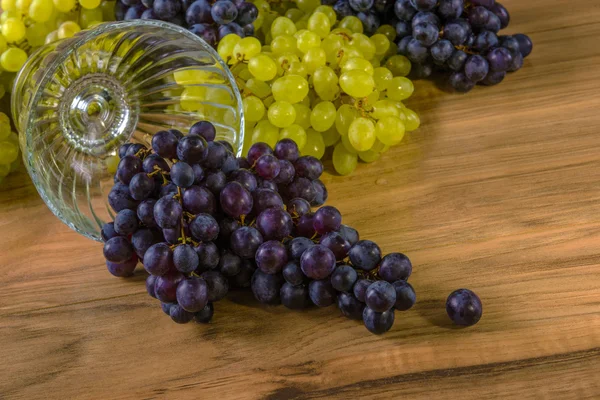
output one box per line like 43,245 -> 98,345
115,0 -> 258,47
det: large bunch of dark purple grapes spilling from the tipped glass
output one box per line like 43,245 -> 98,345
102,121 -> 416,334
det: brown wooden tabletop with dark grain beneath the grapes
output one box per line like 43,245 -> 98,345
0,0 -> 600,400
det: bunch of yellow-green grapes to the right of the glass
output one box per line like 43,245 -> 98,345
217,0 -> 420,175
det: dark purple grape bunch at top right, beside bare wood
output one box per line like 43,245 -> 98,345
394,0 -> 533,92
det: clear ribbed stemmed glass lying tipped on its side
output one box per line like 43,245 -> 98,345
12,20 -> 244,241
